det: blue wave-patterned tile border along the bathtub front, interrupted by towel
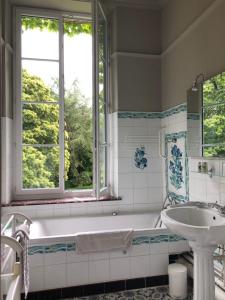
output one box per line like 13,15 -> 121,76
28,234 -> 185,255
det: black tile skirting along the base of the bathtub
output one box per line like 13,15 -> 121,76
21,275 -> 168,300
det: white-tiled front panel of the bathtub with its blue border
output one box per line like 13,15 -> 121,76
29,233 -> 189,291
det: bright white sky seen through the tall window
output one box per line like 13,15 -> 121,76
22,29 -> 92,103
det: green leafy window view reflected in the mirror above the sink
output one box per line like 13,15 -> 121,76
203,72 -> 225,156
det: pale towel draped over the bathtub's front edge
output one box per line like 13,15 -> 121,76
75,229 -> 134,254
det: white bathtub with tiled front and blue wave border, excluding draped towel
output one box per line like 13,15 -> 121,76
28,212 -> 189,291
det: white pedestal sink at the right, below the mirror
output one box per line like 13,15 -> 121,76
161,202 -> 225,300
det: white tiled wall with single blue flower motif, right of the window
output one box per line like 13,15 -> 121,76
115,113 -> 163,211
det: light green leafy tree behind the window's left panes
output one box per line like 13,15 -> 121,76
22,70 -> 69,188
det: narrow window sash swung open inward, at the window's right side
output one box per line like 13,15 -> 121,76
93,0 -> 109,198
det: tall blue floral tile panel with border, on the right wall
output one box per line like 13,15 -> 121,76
165,131 -> 188,202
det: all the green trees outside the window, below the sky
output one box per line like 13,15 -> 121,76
22,70 -> 92,188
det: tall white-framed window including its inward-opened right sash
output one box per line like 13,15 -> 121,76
15,1 -> 109,199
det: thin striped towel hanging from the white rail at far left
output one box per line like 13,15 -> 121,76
14,225 -> 30,299
